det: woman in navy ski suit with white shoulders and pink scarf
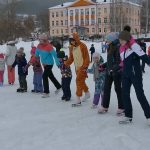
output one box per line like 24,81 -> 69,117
119,31 -> 150,125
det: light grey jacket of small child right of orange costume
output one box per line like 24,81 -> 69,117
87,56 -> 105,81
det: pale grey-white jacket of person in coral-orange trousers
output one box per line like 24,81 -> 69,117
5,45 -> 17,66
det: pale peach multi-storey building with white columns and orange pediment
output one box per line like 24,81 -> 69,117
49,0 -> 141,37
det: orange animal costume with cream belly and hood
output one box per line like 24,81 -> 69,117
65,32 -> 90,97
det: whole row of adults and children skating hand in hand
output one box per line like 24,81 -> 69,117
0,25 -> 150,126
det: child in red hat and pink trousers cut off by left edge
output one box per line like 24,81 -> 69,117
0,53 -> 5,86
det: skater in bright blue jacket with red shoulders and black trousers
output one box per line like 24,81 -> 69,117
35,34 -> 61,98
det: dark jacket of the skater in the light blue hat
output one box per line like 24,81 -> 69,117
103,42 -> 121,75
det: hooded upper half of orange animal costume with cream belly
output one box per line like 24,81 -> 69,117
65,32 -> 90,71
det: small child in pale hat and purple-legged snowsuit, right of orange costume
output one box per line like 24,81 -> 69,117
87,52 -> 105,108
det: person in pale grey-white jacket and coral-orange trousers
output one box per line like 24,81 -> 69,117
5,41 -> 17,85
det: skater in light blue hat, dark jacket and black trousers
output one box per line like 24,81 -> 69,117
98,33 -> 124,115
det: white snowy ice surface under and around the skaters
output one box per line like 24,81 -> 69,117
0,42 -> 150,150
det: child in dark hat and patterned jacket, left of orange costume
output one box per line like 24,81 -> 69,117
57,51 -> 72,101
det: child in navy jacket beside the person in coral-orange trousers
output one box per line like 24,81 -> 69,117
12,47 -> 28,92
